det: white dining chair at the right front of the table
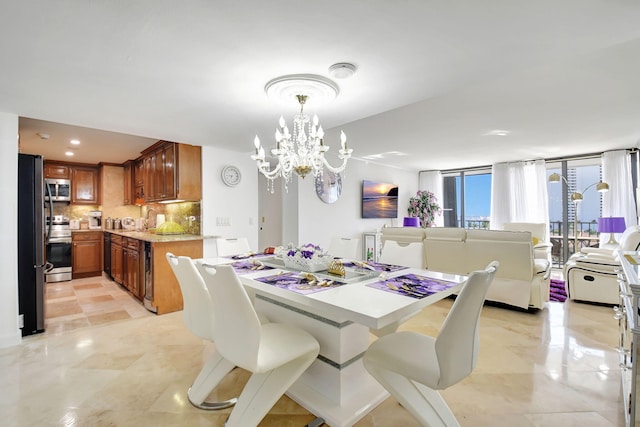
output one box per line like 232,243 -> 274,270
363,261 -> 498,427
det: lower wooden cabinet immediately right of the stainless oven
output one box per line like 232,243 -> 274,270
71,231 -> 103,279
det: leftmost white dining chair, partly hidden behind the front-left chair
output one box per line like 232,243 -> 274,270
166,252 -> 237,410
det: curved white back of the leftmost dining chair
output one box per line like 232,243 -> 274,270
166,252 -> 214,341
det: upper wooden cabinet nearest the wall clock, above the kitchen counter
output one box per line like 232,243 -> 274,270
142,141 -> 202,202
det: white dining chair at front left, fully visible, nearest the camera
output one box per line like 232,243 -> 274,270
197,263 -> 320,427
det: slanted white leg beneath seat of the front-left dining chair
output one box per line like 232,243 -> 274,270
225,352 -> 317,427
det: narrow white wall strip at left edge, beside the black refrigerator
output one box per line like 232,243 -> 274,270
0,113 -> 22,348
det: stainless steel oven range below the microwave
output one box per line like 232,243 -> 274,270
45,215 -> 72,283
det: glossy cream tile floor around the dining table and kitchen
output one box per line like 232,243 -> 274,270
0,272 -> 624,427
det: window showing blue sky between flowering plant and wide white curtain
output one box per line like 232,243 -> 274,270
442,169 -> 491,229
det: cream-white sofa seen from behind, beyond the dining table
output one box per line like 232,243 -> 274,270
382,227 -> 551,310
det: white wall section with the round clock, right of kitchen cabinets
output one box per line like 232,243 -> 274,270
201,146 -> 259,258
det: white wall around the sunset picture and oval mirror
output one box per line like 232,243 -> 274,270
296,159 -> 418,253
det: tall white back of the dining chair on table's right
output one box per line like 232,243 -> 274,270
435,261 -> 499,389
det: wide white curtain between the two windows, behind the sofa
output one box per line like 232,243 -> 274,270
491,160 -> 549,230
